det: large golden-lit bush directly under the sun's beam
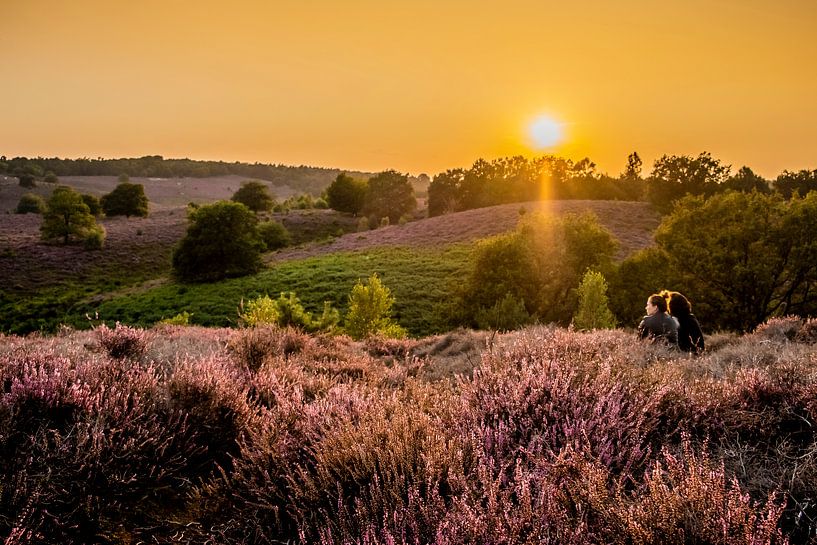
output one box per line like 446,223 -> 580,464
454,210 -> 617,325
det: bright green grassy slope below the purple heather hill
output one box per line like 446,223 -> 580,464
67,244 -> 472,336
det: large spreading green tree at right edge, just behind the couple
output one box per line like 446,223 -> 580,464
655,192 -> 817,331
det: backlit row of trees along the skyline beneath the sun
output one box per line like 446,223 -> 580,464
428,152 -> 817,216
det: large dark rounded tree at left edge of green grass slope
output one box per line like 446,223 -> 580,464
173,201 -> 264,282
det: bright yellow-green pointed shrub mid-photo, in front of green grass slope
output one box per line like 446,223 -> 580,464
344,274 -> 406,340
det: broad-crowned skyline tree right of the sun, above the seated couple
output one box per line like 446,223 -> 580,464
647,152 -> 730,213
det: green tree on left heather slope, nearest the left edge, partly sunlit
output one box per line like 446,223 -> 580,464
40,185 -> 97,244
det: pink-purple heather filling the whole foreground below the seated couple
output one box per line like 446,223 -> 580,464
0,318 -> 817,544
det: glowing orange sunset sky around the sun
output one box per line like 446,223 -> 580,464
0,0 -> 817,177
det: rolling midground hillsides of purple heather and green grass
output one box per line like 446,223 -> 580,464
0,177 -> 658,336
